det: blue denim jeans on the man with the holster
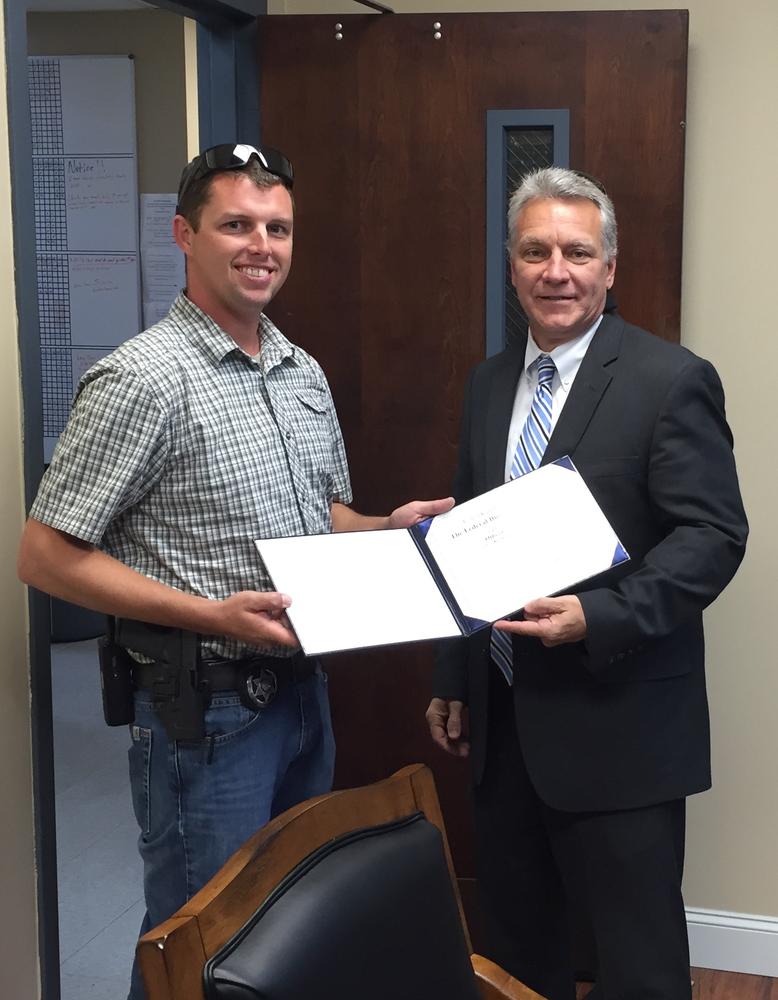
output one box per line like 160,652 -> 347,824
129,670 -> 335,1000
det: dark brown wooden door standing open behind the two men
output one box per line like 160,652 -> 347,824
259,11 -> 687,940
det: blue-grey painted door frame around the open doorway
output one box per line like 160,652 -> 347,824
4,0 -> 267,1000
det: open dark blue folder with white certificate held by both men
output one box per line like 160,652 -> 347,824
255,458 -> 629,654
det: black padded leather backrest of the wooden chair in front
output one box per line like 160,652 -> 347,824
203,813 -> 480,1000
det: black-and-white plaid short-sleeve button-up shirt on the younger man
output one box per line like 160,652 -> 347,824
30,293 -> 351,658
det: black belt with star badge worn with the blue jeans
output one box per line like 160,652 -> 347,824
132,653 -> 318,707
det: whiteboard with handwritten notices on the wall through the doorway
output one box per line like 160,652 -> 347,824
28,56 -> 141,461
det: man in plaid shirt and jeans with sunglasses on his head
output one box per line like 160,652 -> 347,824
19,145 -> 453,1000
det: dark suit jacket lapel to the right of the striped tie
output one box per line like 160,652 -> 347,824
541,315 -> 624,465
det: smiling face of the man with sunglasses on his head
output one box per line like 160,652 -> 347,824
173,172 -> 293,353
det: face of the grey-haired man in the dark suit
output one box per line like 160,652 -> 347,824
511,198 -> 616,352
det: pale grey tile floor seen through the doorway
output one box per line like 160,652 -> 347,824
51,640 -> 144,1000
